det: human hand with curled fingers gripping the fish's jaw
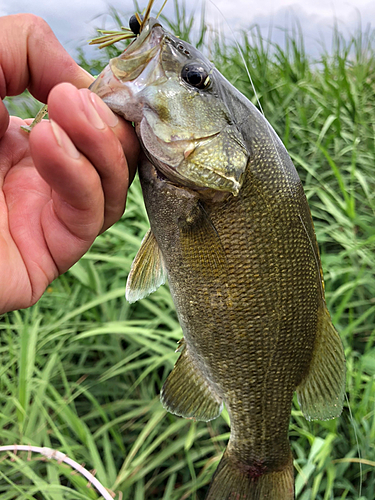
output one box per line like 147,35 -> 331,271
0,14 -> 139,313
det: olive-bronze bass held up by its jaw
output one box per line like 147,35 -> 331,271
91,14 -> 345,500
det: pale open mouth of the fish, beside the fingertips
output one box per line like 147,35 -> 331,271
89,18 -> 165,98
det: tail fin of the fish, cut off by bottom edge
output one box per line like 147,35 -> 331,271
205,449 -> 294,500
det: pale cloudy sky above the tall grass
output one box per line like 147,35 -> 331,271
0,0 -> 375,57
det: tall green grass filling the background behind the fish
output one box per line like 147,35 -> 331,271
0,2 -> 375,500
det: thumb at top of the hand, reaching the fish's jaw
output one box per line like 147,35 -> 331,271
0,14 -> 93,102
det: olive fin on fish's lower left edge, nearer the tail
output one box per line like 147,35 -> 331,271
160,347 -> 223,422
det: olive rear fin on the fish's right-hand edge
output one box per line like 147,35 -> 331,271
297,308 -> 345,420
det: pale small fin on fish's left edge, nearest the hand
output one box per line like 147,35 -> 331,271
125,229 -> 166,303
